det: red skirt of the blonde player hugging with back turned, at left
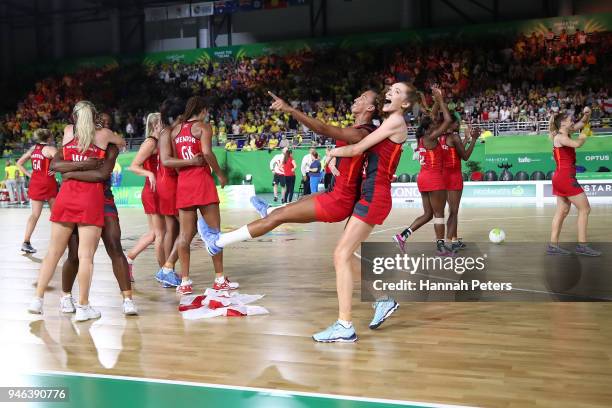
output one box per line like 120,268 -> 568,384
50,180 -> 104,227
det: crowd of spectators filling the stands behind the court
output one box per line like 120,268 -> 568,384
0,25 -> 612,154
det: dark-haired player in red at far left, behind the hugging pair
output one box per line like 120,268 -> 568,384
17,129 -> 57,254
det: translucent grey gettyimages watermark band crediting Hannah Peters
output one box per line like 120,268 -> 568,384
361,242 -> 612,302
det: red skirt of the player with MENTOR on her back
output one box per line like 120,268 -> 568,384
176,167 -> 219,209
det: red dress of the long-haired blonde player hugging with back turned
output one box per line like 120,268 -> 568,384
51,137 -> 106,227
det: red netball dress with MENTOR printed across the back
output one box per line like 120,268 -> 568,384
174,121 -> 219,209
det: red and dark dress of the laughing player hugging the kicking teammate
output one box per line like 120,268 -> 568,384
353,139 -> 403,225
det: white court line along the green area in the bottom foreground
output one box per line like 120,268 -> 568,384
28,370 -> 476,408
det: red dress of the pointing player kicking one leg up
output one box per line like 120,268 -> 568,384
314,124 -> 376,222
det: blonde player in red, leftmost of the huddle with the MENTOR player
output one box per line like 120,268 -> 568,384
127,113 -> 166,282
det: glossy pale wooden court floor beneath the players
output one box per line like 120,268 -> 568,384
0,206 -> 612,407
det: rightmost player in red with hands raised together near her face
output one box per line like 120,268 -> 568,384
546,107 -> 601,256
